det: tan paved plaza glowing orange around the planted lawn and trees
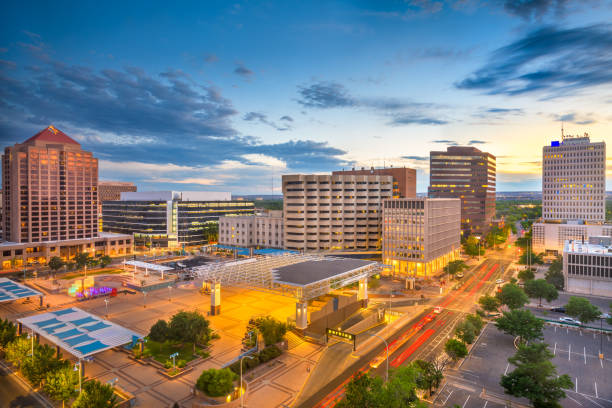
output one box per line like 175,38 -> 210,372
0,278 -> 323,408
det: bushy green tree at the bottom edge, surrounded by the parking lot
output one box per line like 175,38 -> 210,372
500,343 -> 572,408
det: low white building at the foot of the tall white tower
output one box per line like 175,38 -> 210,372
531,222 -> 612,255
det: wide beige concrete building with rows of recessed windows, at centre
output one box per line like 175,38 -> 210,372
282,174 -> 393,251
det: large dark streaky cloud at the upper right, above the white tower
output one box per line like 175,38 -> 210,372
456,24 -> 612,97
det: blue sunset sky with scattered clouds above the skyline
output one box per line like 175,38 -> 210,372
0,0 -> 612,194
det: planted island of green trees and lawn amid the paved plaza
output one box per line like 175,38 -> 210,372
132,311 -> 218,378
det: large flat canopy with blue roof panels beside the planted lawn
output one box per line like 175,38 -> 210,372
17,307 -> 143,359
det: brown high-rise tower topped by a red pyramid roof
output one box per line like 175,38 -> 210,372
2,126 -> 98,243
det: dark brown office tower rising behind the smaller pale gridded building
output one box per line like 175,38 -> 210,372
428,146 -> 496,236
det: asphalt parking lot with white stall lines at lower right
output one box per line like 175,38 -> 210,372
434,324 -> 612,408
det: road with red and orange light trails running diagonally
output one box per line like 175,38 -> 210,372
296,250 -> 513,408
